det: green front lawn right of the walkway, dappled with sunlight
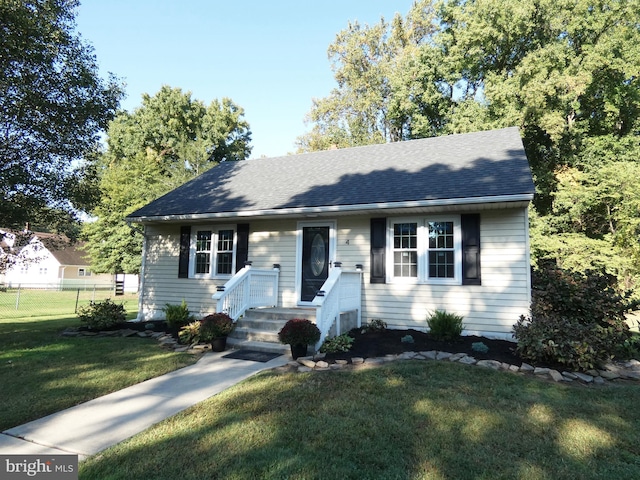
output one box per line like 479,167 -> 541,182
80,361 -> 640,480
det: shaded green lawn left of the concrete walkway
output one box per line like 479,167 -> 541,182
0,312 -> 197,431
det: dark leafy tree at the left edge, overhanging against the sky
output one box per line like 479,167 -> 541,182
0,0 -> 123,230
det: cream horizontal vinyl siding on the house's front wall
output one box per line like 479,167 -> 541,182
142,208 -> 530,337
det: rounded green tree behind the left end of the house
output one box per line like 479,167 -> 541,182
84,86 -> 251,273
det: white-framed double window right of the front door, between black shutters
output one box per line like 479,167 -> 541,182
387,216 -> 462,284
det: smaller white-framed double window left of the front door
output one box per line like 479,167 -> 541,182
189,227 -> 236,278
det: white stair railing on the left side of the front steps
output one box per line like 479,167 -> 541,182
212,263 -> 280,322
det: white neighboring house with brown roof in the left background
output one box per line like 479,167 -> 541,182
0,229 -> 138,292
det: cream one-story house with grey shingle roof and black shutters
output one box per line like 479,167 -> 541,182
128,128 -> 534,344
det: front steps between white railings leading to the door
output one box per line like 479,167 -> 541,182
227,308 -> 316,354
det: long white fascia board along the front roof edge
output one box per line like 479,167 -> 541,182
125,193 -> 533,223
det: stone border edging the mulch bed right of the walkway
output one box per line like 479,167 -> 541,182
280,350 -> 640,385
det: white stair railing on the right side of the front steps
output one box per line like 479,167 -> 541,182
313,262 -> 362,350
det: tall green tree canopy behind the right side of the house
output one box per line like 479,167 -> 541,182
298,0 -> 640,285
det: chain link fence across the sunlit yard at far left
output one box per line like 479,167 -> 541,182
0,285 -> 138,319
